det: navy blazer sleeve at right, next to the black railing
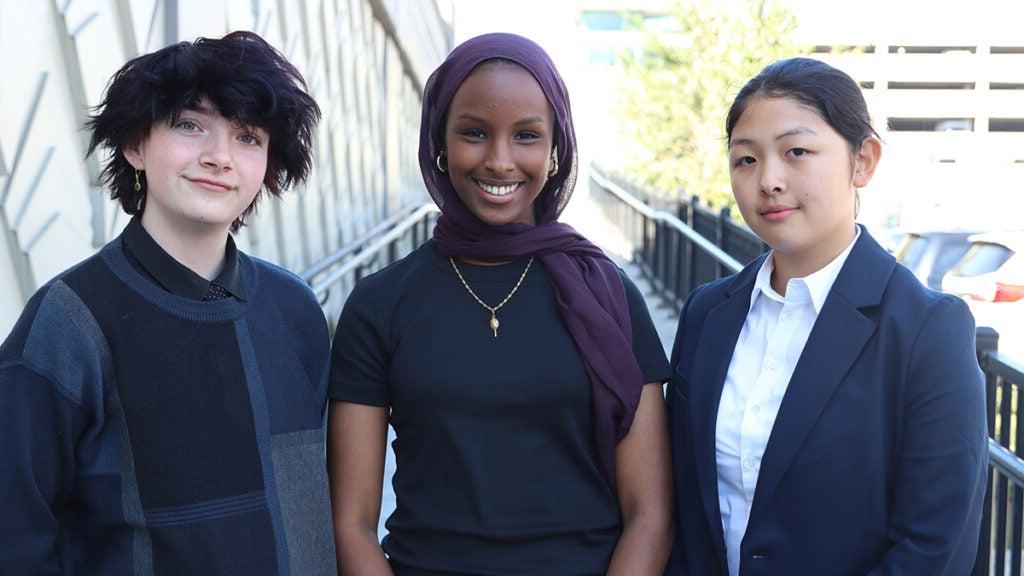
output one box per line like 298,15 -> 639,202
869,296 -> 988,576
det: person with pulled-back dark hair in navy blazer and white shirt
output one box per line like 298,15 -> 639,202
666,58 -> 988,576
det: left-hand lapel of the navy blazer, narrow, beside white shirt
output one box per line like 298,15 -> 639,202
689,257 -> 764,566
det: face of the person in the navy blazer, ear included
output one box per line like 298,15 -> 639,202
729,96 -> 880,276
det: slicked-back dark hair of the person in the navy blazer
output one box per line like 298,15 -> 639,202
725,57 -> 878,152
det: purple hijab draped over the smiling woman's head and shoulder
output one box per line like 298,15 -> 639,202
420,34 -> 644,479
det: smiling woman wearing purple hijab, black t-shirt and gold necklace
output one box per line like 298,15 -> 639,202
328,34 -> 672,576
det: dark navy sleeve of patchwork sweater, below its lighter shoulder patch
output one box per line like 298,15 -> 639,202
0,362 -> 87,576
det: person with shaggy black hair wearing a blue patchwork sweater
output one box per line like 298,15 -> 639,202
0,32 -> 336,576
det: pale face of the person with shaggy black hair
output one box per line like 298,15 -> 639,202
124,105 -> 270,235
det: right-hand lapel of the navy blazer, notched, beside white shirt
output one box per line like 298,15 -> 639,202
751,229 -> 896,512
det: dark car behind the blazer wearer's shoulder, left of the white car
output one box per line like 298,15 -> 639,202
893,230 -> 978,290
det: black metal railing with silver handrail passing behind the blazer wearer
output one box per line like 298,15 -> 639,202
590,162 -> 1024,576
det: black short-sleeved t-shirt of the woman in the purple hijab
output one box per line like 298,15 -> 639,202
330,242 -> 670,576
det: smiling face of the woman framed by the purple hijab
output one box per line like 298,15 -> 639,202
444,65 -> 554,225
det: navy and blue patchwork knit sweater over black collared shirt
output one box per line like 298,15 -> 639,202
0,239 -> 335,575
